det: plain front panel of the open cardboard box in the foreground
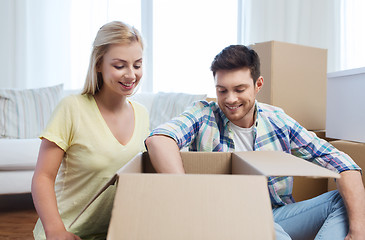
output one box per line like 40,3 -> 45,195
107,174 -> 275,240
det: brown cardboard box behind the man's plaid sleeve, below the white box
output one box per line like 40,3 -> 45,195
328,140 -> 365,191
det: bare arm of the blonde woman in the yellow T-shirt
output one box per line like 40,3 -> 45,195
32,139 -> 80,239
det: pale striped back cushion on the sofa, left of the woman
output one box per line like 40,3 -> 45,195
0,84 -> 63,138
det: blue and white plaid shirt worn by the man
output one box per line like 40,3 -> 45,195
151,101 -> 361,207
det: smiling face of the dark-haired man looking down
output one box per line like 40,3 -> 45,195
214,68 -> 263,128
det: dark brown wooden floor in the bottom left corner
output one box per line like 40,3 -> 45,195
0,194 -> 38,240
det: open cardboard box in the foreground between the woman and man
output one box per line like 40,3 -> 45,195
70,151 -> 339,240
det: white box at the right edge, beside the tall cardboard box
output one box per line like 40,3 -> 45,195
326,68 -> 365,143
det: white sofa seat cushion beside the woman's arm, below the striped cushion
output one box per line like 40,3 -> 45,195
0,138 -> 41,171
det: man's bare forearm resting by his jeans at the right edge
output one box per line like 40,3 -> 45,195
337,170 -> 365,240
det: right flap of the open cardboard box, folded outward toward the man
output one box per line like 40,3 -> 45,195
232,151 -> 340,178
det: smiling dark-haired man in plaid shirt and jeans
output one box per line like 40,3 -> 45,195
146,45 -> 365,240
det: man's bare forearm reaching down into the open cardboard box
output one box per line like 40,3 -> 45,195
145,135 -> 185,174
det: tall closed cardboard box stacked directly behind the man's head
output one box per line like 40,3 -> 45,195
250,41 -> 327,130
